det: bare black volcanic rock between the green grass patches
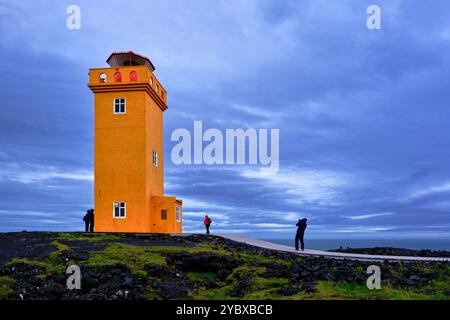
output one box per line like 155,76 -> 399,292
0,232 -> 450,299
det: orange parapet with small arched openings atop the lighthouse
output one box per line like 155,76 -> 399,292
89,66 -> 167,103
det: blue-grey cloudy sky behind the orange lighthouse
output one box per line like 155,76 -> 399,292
0,0 -> 450,239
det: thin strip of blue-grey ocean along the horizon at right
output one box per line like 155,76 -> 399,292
262,239 -> 450,251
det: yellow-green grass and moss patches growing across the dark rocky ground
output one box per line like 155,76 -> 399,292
4,233 -> 450,300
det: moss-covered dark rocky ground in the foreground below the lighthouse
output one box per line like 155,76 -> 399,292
0,232 -> 450,299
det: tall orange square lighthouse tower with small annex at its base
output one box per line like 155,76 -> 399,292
88,51 -> 182,233
